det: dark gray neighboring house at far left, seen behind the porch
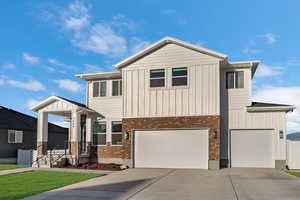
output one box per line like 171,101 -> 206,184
0,106 -> 68,163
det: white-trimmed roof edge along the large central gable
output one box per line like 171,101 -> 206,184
113,37 -> 228,69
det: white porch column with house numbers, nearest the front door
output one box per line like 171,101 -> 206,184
69,110 -> 80,157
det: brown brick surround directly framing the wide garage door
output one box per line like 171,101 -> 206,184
123,116 -> 220,160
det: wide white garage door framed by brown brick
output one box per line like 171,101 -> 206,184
134,130 -> 208,169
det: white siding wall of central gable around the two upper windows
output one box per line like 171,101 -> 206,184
122,44 -> 220,118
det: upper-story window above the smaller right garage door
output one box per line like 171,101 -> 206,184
226,71 -> 244,89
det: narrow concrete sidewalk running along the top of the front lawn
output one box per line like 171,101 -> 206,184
0,167 -> 115,176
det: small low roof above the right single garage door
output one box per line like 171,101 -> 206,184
247,101 -> 296,112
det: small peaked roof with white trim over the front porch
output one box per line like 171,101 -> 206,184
30,96 -> 94,112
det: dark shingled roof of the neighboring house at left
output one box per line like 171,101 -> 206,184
0,106 -> 68,133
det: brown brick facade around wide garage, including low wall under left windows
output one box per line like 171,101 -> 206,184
97,116 -> 220,164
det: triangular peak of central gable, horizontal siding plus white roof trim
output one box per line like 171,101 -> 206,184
114,37 -> 227,69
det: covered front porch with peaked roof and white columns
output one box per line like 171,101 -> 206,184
31,96 -> 96,167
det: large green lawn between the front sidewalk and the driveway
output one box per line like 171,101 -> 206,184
0,171 -> 104,200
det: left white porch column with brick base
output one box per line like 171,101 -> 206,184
37,111 -> 48,155
